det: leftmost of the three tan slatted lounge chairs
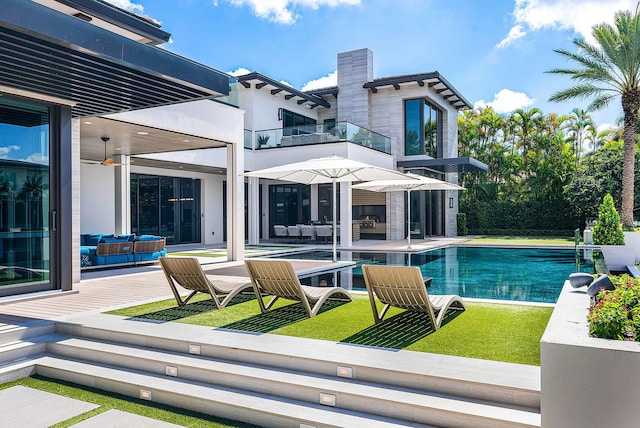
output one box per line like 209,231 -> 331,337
158,257 -> 251,309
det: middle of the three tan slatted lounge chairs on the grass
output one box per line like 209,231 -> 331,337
244,259 -> 353,318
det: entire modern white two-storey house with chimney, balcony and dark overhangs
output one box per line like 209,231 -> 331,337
0,0 -> 486,296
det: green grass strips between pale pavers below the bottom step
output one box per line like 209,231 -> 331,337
0,375 -> 255,428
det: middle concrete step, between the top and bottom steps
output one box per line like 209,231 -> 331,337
47,336 -> 540,427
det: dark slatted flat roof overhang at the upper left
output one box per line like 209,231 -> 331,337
0,0 -> 229,117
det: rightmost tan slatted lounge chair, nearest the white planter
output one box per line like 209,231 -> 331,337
362,265 -> 465,330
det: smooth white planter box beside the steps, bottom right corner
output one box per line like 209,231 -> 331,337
540,281 -> 640,428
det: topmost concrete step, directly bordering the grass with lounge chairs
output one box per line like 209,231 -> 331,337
57,315 -> 540,411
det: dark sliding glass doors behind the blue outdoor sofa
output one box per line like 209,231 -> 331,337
131,174 -> 202,244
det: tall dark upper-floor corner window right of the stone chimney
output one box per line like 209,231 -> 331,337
404,99 -> 442,158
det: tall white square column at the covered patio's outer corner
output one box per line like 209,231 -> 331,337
227,137 -> 244,261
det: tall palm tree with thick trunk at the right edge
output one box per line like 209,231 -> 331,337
548,5 -> 640,227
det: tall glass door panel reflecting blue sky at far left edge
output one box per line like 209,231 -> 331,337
0,97 -> 50,295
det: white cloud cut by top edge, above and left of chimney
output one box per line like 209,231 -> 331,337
220,0 -> 360,24
